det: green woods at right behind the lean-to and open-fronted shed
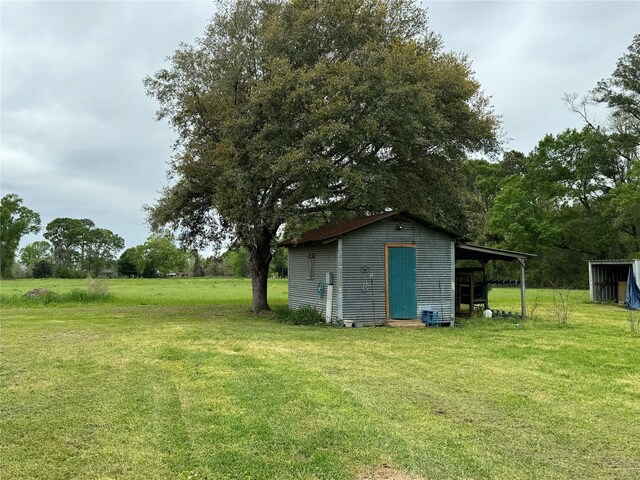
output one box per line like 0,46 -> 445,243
468,35 -> 640,287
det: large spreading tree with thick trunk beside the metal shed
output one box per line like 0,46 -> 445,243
145,0 -> 498,312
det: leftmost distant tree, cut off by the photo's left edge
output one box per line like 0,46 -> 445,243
0,193 -> 40,278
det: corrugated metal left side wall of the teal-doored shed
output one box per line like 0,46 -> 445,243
288,242 -> 338,317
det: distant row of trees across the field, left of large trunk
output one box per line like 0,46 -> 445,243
0,193 -> 287,278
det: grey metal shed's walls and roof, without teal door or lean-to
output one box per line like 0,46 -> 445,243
281,212 -> 460,325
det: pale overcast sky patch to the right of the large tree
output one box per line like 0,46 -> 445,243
426,1 -> 640,153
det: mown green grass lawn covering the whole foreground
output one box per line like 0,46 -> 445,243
0,279 -> 640,480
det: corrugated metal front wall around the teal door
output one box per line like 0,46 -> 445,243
342,218 -> 454,325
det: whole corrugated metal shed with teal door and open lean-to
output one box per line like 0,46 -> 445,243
280,212 -> 530,325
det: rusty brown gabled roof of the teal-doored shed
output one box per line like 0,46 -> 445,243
279,211 -> 463,247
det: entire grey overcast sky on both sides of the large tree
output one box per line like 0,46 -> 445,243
0,0 -> 640,253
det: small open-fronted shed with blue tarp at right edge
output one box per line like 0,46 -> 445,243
589,259 -> 640,303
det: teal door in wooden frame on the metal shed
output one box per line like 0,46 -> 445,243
387,246 -> 418,319
